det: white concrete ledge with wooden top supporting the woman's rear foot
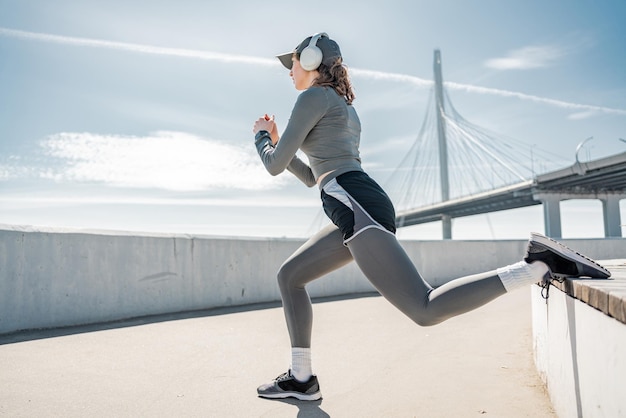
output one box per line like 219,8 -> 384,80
531,259 -> 626,417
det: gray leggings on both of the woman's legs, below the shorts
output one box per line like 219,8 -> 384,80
278,225 -> 506,348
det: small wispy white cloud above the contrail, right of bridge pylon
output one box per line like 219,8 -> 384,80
485,45 -> 565,70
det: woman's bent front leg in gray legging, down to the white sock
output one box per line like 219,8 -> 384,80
278,225 -> 352,348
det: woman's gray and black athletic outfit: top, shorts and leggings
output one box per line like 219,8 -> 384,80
255,87 -> 520,347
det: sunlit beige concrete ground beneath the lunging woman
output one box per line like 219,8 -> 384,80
0,290 -> 555,418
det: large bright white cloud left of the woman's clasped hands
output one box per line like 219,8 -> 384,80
0,132 -> 286,191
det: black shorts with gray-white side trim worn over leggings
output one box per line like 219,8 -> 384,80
321,171 -> 396,244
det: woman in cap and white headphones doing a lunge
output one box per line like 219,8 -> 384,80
253,33 -> 610,400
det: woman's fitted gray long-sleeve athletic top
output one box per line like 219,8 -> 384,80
256,87 -> 362,188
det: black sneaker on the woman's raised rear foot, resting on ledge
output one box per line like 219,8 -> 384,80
524,232 -> 611,280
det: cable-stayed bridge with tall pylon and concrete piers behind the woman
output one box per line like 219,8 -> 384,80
386,50 -> 626,239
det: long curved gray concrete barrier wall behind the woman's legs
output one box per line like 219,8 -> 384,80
0,226 -> 626,334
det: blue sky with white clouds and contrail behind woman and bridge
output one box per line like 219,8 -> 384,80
0,0 -> 626,239
